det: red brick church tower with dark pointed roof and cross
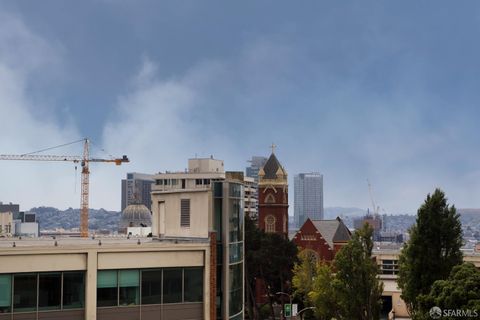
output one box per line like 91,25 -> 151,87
258,145 -> 288,238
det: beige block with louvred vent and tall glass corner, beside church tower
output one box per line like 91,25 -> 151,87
152,158 -> 244,319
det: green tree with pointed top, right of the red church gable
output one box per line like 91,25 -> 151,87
309,224 -> 383,320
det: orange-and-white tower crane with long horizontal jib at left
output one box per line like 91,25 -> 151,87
0,138 -> 130,238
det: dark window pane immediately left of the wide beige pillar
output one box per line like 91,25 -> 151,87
63,272 -> 85,309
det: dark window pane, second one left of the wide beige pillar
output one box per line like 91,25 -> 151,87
38,272 -> 62,310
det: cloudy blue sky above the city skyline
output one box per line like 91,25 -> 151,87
0,0 -> 480,214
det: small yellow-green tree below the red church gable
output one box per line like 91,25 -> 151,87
292,249 -> 318,306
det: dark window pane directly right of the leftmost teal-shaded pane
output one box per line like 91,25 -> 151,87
13,273 -> 37,312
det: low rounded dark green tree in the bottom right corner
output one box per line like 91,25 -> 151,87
417,263 -> 480,319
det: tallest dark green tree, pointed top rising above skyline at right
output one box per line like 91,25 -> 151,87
398,189 -> 462,319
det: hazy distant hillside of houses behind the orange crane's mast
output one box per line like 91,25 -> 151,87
30,207 -> 121,231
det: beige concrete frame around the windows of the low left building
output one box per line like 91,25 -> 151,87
0,239 -> 210,320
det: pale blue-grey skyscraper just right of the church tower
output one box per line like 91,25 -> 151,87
294,172 -> 323,228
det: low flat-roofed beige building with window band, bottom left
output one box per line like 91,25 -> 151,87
0,238 -> 211,320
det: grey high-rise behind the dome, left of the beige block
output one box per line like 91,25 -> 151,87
121,172 -> 154,211
